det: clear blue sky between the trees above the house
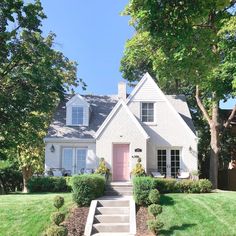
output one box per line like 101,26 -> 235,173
41,0 -> 235,108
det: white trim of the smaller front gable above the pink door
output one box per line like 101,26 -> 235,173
94,99 -> 149,139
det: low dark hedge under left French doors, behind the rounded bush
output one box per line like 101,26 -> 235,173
27,176 -> 71,193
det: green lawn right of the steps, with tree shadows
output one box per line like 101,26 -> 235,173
159,192 -> 236,236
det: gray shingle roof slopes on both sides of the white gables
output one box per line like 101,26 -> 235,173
46,95 -> 195,139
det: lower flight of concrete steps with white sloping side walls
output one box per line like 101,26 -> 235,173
85,197 -> 136,236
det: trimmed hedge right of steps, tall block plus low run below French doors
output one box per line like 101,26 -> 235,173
133,176 -> 212,205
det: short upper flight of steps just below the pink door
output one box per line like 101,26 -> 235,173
105,182 -> 133,196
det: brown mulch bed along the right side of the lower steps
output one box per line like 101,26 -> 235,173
136,207 -> 155,236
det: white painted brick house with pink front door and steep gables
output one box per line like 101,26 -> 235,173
45,73 -> 198,181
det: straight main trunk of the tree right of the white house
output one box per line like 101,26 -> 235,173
210,98 -> 220,188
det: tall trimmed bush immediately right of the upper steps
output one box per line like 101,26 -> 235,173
133,177 -> 154,205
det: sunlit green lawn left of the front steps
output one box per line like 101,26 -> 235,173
0,193 -> 73,236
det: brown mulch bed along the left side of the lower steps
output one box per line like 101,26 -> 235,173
63,207 -> 89,236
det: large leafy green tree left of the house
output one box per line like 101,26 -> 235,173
0,0 -> 85,190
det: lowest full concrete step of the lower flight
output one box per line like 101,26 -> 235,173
92,223 -> 130,233
